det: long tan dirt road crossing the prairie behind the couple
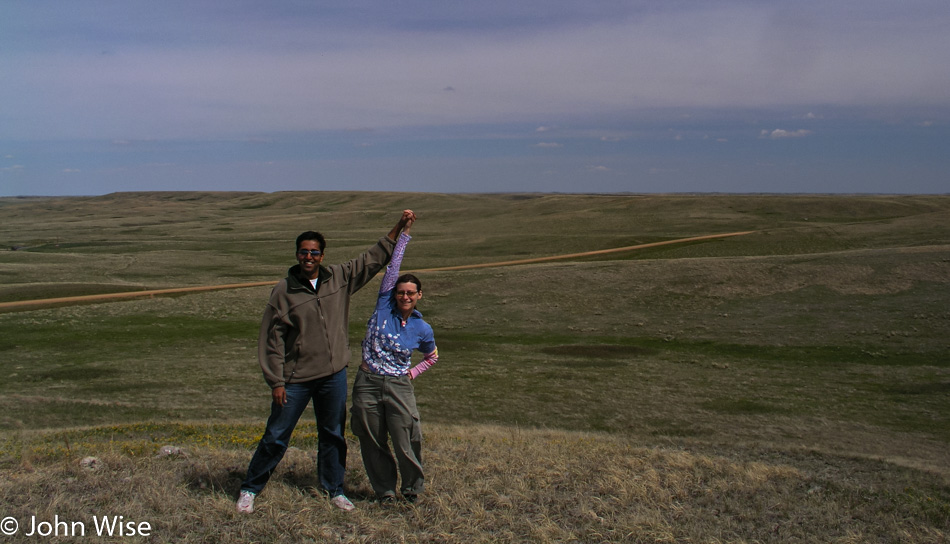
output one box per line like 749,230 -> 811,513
0,230 -> 755,311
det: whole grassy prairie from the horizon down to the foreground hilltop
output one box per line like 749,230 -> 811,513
0,192 -> 950,543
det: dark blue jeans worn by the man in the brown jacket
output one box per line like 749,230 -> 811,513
241,368 -> 346,497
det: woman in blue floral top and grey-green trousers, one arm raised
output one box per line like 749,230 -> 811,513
352,215 -> 439,502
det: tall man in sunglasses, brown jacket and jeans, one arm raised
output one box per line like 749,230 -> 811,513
237,210 -> 415,513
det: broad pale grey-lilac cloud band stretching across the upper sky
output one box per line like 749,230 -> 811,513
0,0 -> 950,140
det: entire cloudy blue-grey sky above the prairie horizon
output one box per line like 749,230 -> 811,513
0,0 -> 950,196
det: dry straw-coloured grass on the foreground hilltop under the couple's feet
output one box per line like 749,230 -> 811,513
0,425 -> 948,543
